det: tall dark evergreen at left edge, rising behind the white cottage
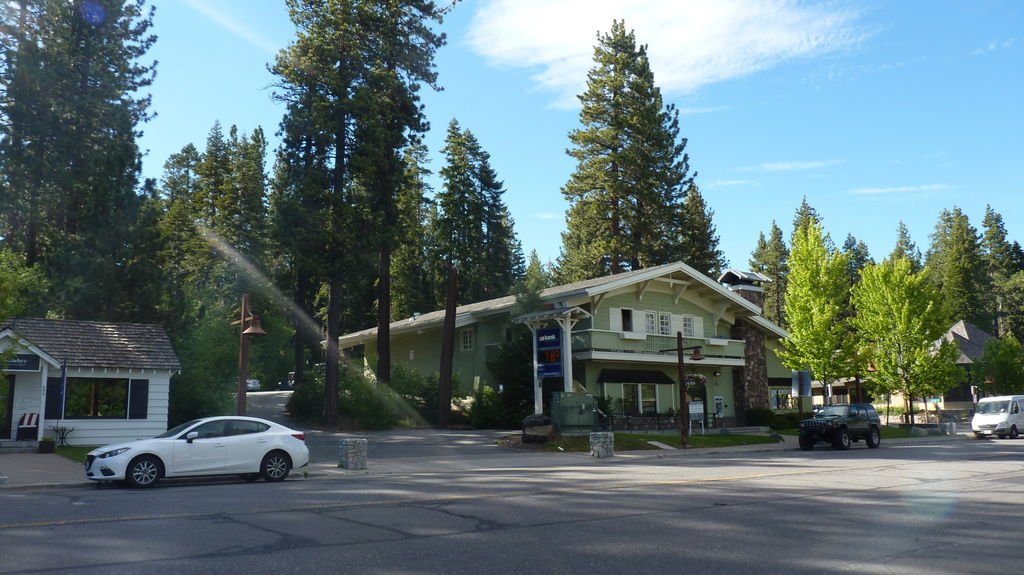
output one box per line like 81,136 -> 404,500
0,0 -> 156,319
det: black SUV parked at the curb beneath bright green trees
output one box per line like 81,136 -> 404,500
800,403 -> 882,451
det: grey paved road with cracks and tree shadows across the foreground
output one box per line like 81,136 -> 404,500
0,431 -> 1024,575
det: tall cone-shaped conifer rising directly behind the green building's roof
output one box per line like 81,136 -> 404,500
558,20 -> 692,281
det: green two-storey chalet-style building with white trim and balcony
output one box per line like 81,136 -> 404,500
339,262 -> 792,427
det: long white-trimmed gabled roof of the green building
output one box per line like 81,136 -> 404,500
338,262 -> 786,349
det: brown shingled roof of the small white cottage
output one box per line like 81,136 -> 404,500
0,317 -> 181,371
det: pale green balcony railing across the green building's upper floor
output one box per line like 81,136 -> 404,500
572,329 -> 744,359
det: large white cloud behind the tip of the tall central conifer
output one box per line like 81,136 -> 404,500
467,0 -> 869,108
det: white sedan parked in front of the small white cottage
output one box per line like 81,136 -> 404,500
85,416 -> 309,487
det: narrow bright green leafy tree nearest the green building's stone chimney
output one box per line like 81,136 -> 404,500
778,219 -> 855,399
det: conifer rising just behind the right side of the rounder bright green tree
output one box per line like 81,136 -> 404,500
925,208 -> 994,331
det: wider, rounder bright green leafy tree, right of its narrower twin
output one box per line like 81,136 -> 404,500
853,258 -> 962,416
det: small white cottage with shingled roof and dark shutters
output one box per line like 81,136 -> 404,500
0,318 -> 181,445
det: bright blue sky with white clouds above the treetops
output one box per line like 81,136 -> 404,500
140,0 -> 1024,269
